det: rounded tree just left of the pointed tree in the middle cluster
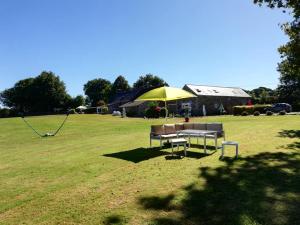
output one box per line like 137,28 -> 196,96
83,78 -> 112,106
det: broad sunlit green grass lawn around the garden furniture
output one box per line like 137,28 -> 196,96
0,115 -> 300,225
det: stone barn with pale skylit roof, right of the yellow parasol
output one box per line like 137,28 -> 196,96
182,84 -> 251,116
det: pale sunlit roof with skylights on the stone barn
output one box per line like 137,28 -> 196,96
183,84 -> 251,98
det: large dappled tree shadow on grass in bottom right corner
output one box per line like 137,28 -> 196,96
139,152 -> 300,225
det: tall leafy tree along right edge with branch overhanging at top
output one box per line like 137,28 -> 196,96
254,0 -> 300,109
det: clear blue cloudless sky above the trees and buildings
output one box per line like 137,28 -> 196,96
0,0 -> 290,96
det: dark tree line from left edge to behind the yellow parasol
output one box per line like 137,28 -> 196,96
0,71 -> 168,114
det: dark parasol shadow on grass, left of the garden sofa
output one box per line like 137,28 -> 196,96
103,147 -> 170,163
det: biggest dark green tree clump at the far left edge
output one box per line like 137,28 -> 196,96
0,71 -> 68,113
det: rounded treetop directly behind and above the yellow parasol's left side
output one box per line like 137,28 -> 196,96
133,74 -> 168,89
